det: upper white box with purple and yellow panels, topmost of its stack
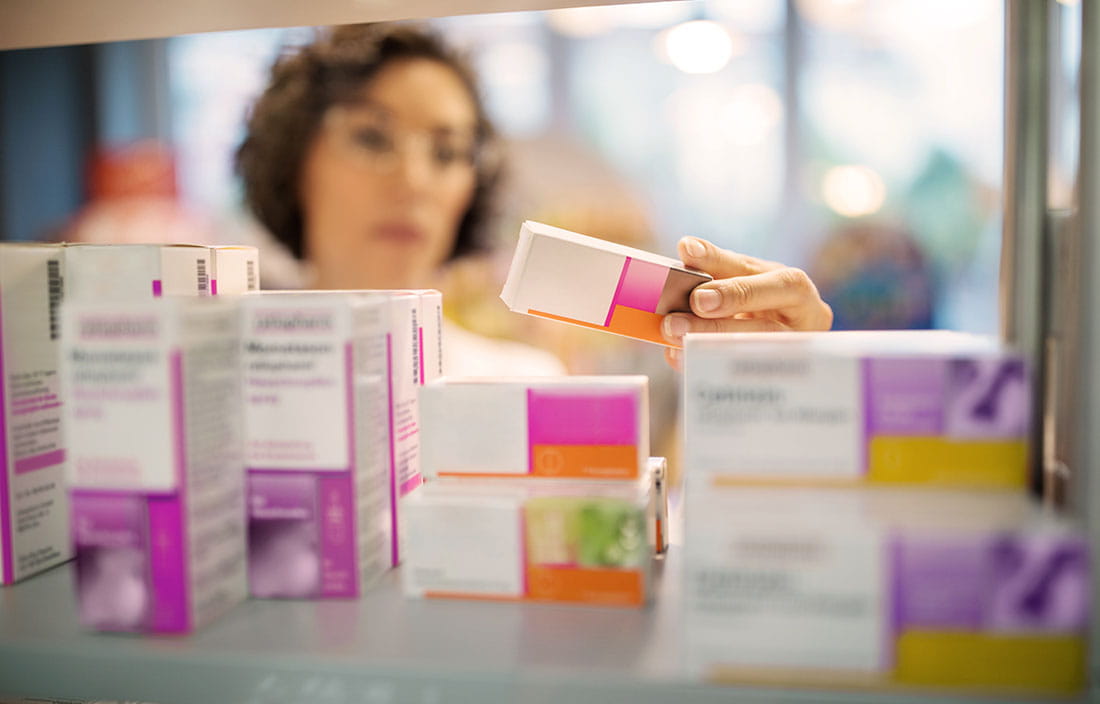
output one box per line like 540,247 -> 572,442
684,331 -> 1031,488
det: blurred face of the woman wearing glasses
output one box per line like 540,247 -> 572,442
299,58 -> 477,288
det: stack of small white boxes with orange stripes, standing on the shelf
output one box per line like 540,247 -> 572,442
403,376 -> 667,606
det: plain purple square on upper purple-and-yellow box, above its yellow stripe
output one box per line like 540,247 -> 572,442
864,358 -> 947,439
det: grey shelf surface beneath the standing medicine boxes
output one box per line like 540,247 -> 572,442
0,550 -> 1084,704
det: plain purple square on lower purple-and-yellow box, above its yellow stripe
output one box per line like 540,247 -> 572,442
892,536 -> 989,631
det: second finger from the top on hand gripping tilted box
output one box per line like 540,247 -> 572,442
691,266 -> 824,329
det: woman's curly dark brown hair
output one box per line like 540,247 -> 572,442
237,23 -> 501,261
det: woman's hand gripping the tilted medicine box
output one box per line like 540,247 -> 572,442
661,238 -> 833,370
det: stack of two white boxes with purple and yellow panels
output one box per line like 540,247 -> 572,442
684,332 -> 1088,693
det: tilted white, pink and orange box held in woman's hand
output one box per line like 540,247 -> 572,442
501,220 -> 711,345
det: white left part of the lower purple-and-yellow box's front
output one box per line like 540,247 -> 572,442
684,526 -> 890,671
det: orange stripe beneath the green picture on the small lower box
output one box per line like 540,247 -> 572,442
527,564 -> 646,606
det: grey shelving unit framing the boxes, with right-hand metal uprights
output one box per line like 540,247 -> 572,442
0,0 -> 1100,704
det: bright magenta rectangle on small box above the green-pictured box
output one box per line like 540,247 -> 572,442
527,386 -> 639,447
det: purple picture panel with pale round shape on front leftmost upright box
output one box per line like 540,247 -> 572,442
70,491 -> 155,631
